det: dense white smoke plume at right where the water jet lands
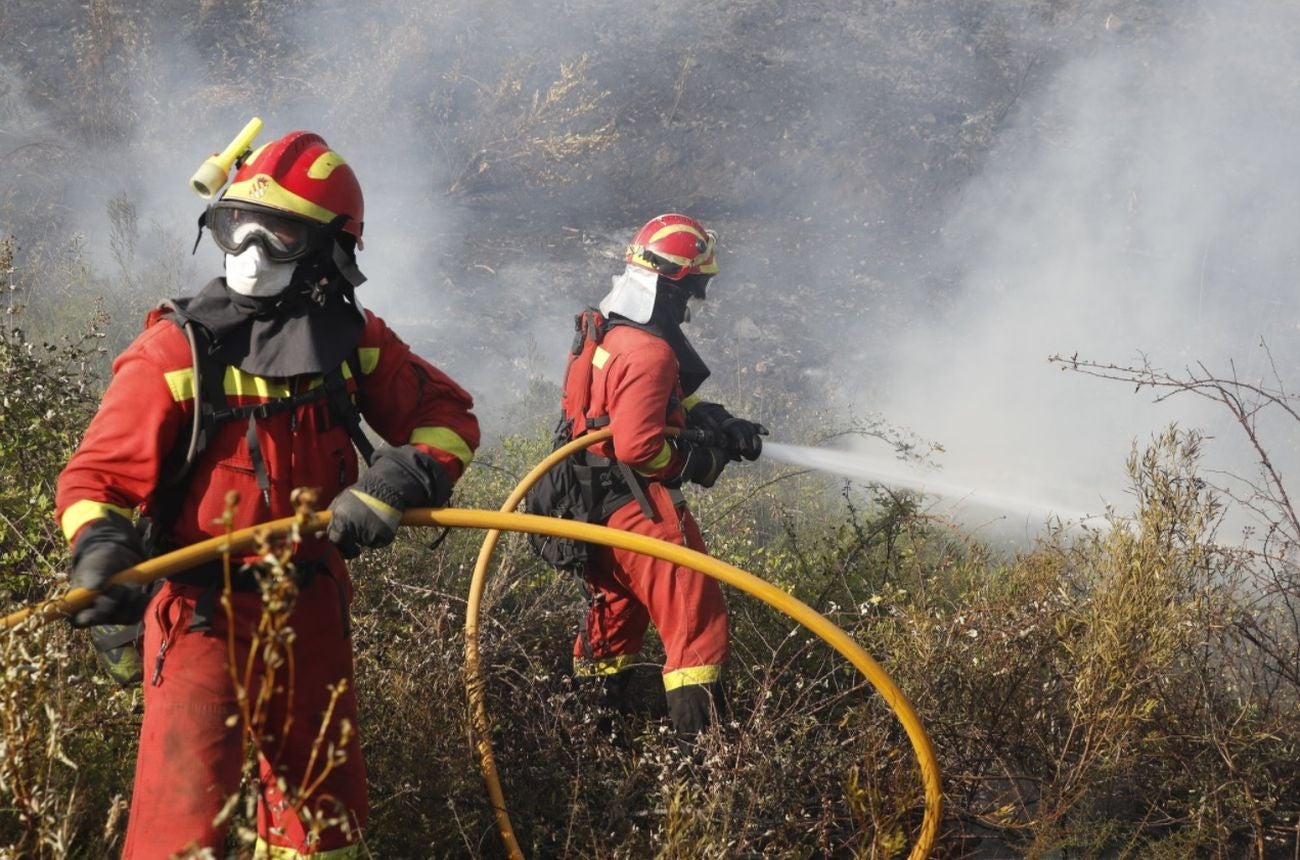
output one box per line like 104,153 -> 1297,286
875,3 -> 1300,532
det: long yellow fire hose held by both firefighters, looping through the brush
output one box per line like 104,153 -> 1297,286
0,498 -> 943,860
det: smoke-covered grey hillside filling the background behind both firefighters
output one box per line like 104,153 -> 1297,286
0,0 -> 1300,535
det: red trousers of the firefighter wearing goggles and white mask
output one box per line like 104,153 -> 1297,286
122,559 -> 367,860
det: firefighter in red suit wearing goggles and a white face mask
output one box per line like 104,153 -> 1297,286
57,131 -> 478,860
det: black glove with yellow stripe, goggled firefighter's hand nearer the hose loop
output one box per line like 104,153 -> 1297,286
329,446 -> 451,559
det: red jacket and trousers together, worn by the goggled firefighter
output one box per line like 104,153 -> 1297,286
56,302 -> 478,860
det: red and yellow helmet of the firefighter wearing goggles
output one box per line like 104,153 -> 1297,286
216,131 -> 365,238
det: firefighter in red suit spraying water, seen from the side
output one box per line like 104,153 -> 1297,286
566,214 -> 767,748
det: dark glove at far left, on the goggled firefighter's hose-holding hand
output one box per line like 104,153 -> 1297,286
69,513 -> 150,627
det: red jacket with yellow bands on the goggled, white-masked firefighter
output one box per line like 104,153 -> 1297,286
56,310 -> 478,559
